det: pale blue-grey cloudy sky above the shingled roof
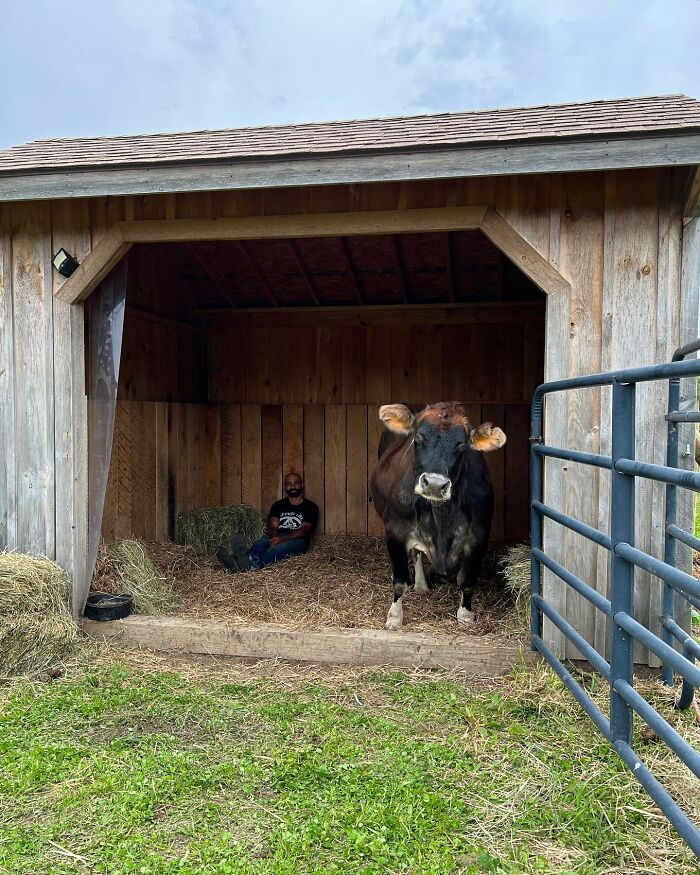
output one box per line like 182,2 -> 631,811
0,0 -> 700,148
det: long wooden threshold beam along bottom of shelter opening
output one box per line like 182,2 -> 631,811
82,616 -> 536,677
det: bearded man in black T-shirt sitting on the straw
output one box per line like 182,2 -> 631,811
216,471 -> 318,572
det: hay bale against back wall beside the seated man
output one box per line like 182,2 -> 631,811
175,504 -> 265,556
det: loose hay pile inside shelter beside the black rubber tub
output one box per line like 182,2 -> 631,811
91,538 -> 181,615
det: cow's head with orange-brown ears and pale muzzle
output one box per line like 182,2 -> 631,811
379,401 -> 506,503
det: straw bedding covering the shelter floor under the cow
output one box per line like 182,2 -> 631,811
146,534 -> 519,634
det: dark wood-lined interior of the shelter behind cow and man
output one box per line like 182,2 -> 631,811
88,230 -> 546,620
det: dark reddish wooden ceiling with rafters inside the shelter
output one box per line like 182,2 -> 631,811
134,231 -> 544,311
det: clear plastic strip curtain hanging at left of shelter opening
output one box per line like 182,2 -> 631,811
79,257 -> 129,612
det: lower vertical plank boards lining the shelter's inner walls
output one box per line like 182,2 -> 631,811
102,401 -> 529,544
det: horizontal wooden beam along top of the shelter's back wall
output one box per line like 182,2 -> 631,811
196,301 -> 545,327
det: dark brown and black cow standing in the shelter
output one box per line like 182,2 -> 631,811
371,401 -> 506,631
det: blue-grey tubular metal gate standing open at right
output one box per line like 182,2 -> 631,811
530,340 -> 700,858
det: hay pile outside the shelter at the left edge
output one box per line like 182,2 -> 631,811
0,552 -> 80,676
